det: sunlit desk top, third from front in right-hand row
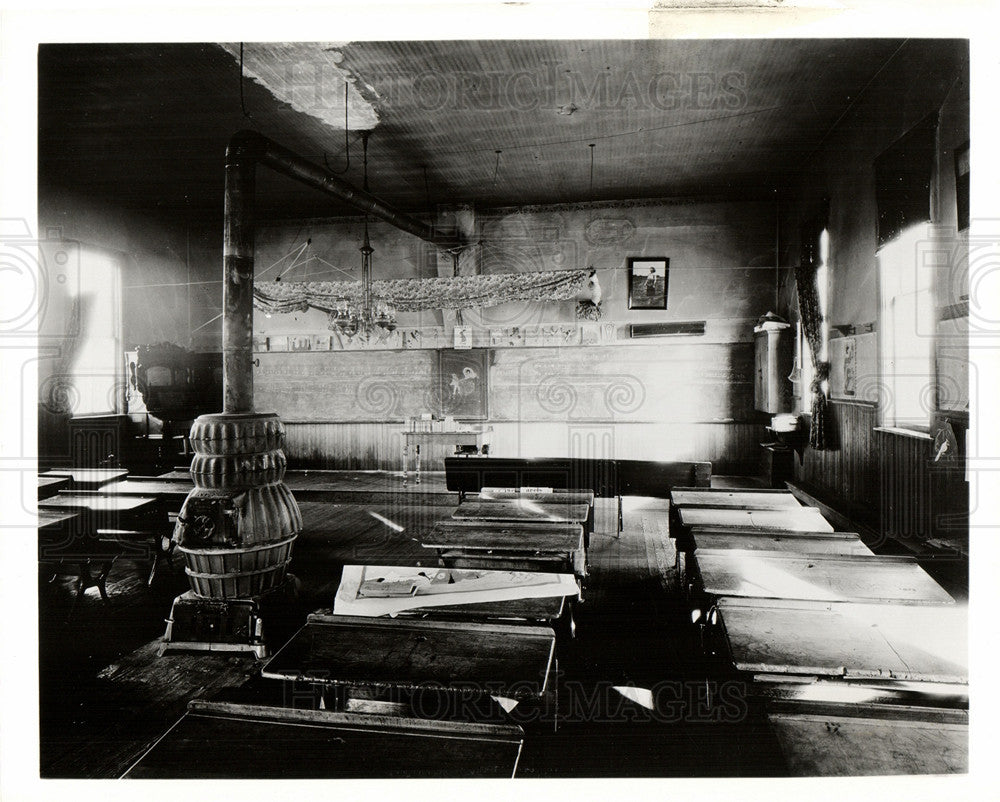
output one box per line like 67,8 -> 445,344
694,549 -> 955,604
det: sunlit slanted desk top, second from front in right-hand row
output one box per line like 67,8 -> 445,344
717,599 -> 969,683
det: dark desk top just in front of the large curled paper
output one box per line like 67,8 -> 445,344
261,614 -> 555,699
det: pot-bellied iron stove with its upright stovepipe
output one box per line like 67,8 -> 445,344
161,135 -> 302,657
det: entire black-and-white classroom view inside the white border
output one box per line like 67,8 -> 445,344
26,38 -> 978,779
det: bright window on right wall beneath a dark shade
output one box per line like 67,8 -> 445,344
878,223 -> 937,428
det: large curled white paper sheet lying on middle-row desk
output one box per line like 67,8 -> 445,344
333,565 -> 580,616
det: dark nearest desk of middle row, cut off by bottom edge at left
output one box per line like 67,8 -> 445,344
124,701 -> 523,780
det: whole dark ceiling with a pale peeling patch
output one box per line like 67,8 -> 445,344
39,39 -> 951,221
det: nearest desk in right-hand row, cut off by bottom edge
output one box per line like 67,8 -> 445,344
767,704 -> 969,777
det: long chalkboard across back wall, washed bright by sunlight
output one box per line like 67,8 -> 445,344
254,339 -> 754,423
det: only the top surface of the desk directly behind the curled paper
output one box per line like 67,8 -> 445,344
421,520 -> 583,554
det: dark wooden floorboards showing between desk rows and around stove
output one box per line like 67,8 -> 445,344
39,482 -> 782,777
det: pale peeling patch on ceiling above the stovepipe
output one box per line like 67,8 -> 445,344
222,42 -> 379,131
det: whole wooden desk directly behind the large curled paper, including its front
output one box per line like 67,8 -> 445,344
421,520 -> 587,578
